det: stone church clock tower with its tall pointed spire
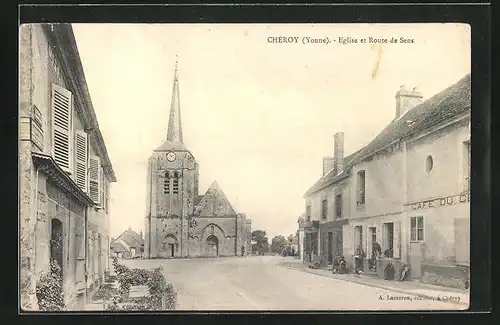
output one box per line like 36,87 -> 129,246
144,62 -> 199,258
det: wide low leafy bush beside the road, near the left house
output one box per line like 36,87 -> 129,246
107,258 -> 177,311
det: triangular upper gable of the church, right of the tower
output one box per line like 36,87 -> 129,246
199,181 -> 236,217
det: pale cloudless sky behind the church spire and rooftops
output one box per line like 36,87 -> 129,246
73,24 -> 470,241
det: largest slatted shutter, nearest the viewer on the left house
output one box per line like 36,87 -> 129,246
52,84 -> 73,172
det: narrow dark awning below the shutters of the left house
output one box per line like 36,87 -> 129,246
31,152 -> 95,206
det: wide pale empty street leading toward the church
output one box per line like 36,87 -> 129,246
120,256 -> 463,311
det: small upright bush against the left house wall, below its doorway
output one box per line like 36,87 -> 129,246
36,260 -> 66,311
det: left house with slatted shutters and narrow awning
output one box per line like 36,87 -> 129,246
19,24 -> 116,310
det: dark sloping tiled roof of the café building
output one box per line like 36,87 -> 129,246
352,74 -> 471,164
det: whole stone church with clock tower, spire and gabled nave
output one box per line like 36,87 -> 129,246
144,66 -> 252,258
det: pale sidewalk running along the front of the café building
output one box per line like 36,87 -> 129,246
279,261 -> 469,306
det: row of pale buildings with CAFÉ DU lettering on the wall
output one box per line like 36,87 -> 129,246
305,74 -> 471,288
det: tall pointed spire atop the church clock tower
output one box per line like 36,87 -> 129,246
156,57 -> 186,151
